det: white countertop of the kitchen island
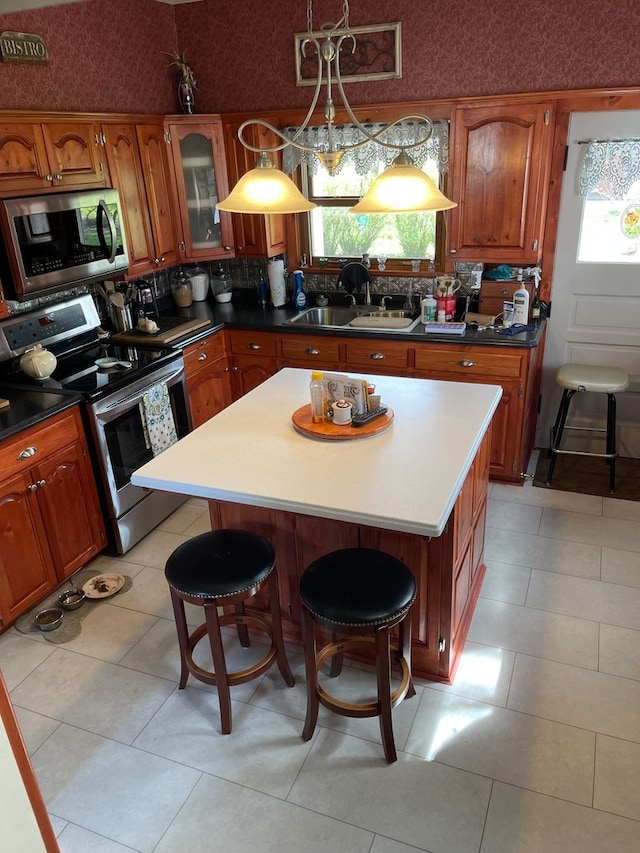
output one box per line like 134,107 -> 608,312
131,368 -> 502,536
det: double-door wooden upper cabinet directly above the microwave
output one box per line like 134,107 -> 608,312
0,115 -> 108,196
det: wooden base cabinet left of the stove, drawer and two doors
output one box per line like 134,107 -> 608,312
0,407 -> 107,628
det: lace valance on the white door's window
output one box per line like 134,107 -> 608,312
579,139 -> 640,199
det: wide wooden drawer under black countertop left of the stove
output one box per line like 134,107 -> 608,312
0,409 -> 81,479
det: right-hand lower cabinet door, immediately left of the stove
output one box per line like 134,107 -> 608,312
33,442 -> 106,581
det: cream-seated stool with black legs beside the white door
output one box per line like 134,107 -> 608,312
546,364 -> 629,492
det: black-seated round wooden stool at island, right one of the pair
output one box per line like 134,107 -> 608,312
300,548 -> 416,762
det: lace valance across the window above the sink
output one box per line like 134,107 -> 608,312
282,121 -> 449,175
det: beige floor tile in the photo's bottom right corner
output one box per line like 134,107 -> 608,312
480,782 -> 640,853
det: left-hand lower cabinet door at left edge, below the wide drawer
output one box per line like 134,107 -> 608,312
0,466 -> 57,627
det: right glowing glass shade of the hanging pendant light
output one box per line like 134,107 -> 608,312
349,153 -> 458,213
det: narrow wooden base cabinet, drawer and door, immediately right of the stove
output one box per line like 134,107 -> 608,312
183,332 -> 233,429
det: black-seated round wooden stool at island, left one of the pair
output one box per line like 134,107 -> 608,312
165,530 -> 295,734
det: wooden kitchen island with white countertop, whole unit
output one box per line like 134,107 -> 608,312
132,368 -> 501,682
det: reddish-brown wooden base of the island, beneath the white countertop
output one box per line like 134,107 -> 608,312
209,431 -> 491,684
